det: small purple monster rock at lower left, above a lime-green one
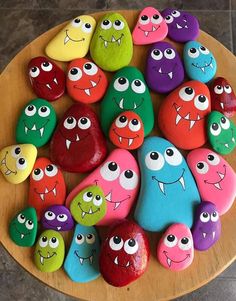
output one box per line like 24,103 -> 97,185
41,205 -> 74,231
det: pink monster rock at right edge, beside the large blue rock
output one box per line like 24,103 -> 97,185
187,148 -> 236,215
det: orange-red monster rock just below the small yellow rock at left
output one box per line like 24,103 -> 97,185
28,158 -> 66,220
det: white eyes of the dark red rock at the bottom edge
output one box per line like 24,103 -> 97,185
109,236 -> 139,255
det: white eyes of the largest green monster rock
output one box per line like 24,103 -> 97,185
113,77 -> 146,94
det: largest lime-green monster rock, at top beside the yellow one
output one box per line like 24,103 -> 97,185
90,13 -> 133,71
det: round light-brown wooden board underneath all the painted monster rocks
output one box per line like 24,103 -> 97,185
0,11 -> 236,301
